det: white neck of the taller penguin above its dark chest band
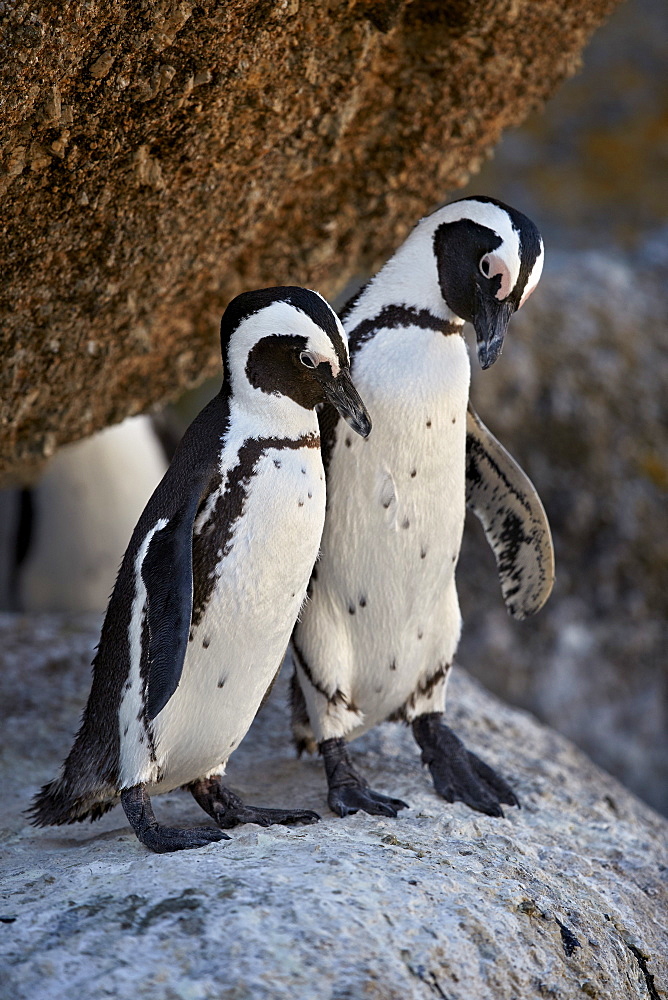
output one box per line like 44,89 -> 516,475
345,218 -> 464,330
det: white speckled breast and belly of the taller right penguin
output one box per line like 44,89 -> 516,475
297,328 -> 470,732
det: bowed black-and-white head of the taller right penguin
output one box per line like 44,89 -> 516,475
428,197 -> 544,368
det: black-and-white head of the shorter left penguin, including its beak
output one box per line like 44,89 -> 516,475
220,285 -> 371,437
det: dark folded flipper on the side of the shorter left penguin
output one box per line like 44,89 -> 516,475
141,495 -> 199,719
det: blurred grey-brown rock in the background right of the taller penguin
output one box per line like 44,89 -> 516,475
458,240 -> 668,812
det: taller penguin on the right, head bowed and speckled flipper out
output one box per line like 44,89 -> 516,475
292,198 -> 553,816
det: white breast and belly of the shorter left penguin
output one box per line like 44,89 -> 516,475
122,448 -> 325,792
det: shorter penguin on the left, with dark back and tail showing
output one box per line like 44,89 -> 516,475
31,287 -> 371,853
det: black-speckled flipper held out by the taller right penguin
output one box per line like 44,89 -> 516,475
466,405 -> 554,619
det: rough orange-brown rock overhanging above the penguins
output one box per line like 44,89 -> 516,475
0,0 -> 615,479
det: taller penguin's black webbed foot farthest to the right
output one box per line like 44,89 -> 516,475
413,712 -> 520,816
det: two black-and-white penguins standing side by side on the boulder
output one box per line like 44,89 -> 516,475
32,198 -> 553,852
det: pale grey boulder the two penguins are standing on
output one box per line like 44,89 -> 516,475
0,615 -> 668,1000
